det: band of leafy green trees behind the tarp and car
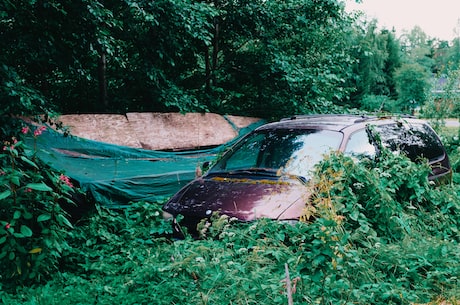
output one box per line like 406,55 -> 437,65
0,0 -> 459,118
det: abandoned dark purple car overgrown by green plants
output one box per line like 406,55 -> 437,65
163,115 -> 452,235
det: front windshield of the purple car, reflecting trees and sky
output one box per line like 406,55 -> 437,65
209,129 -> 343,179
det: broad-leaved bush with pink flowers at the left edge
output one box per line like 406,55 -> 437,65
0,126 -> 75,283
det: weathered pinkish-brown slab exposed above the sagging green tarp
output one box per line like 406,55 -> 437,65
58,112 -> 260,150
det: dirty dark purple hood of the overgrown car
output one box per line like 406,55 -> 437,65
163,173 -> 311,221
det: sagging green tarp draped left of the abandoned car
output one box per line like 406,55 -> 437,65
28,121 -> 263,208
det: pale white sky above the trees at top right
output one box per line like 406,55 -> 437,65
345,0 -> 460,41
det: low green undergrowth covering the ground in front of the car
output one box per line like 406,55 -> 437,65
0,149 -> 460,305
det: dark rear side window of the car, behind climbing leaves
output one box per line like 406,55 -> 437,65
375,123 -> 444,161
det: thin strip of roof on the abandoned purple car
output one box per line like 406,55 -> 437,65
258,114 -> 423,131
